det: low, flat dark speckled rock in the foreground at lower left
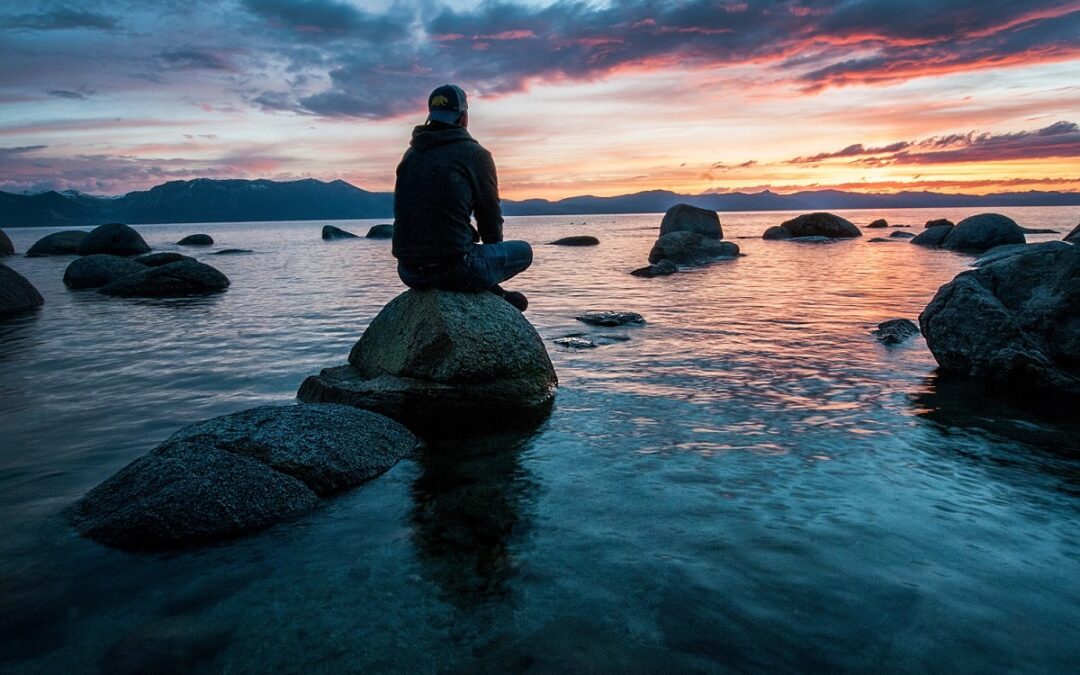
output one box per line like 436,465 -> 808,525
72,405 -> 417,550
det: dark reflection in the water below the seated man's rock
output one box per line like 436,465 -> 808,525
411,431 -> 538,608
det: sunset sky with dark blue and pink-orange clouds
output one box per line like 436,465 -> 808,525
0,0 -> 1080,199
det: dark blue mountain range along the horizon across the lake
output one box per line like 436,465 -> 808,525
0,178 -> 1080,227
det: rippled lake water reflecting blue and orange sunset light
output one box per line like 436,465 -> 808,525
0,207 -> 1080,673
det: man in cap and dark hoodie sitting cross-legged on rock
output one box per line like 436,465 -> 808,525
393,84 -> 532,312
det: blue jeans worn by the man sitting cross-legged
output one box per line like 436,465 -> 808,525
397,241 -> 532,293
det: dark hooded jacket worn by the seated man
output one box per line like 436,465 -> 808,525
393,123 -> 502,266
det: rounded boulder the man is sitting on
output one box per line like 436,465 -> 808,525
297,289 -> 558,434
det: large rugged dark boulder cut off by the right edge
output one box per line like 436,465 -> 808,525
919,242 -> 1080,395
